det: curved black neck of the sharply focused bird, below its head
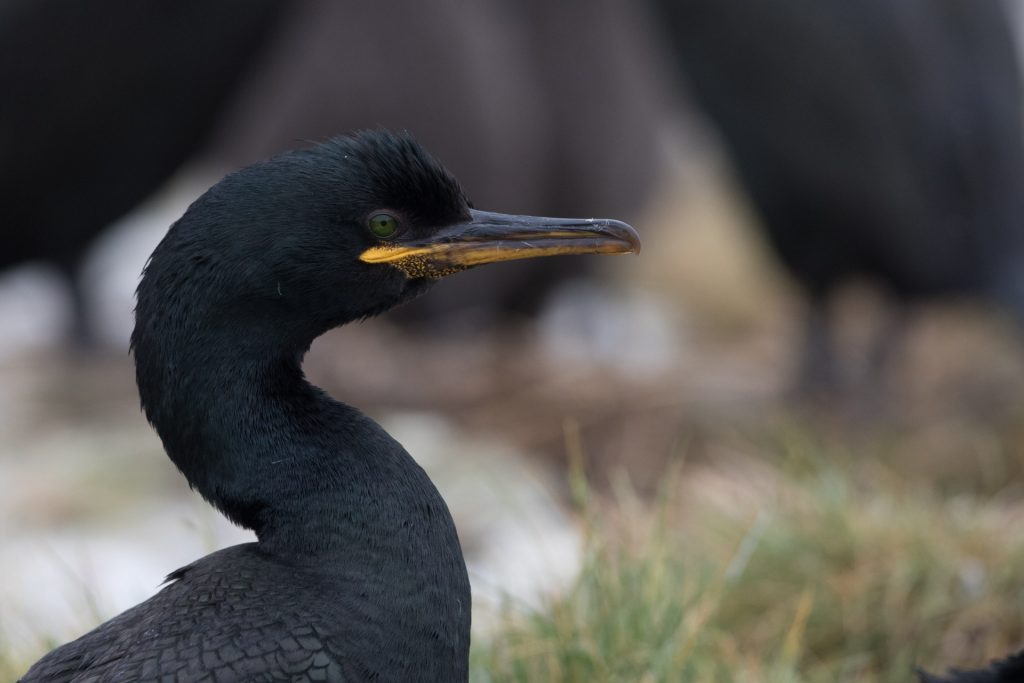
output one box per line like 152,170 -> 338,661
135,325 -> 465,561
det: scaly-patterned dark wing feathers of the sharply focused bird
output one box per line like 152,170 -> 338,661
20,552 -> 358,683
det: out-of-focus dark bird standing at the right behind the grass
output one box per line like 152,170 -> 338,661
655,0 -> 1024,384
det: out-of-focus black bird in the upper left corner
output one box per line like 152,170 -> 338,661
0,0 -> 283,343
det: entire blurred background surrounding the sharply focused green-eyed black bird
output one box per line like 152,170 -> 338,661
6,0 -> 1024,681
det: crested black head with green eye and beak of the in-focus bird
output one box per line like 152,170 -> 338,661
135,131 -> 640,358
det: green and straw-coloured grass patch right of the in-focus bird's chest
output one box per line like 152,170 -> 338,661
472,439 -> 1024,683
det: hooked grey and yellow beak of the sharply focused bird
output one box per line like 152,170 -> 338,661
359,209 -> 640,278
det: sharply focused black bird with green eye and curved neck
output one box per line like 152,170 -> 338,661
16,131 -> 639,683
